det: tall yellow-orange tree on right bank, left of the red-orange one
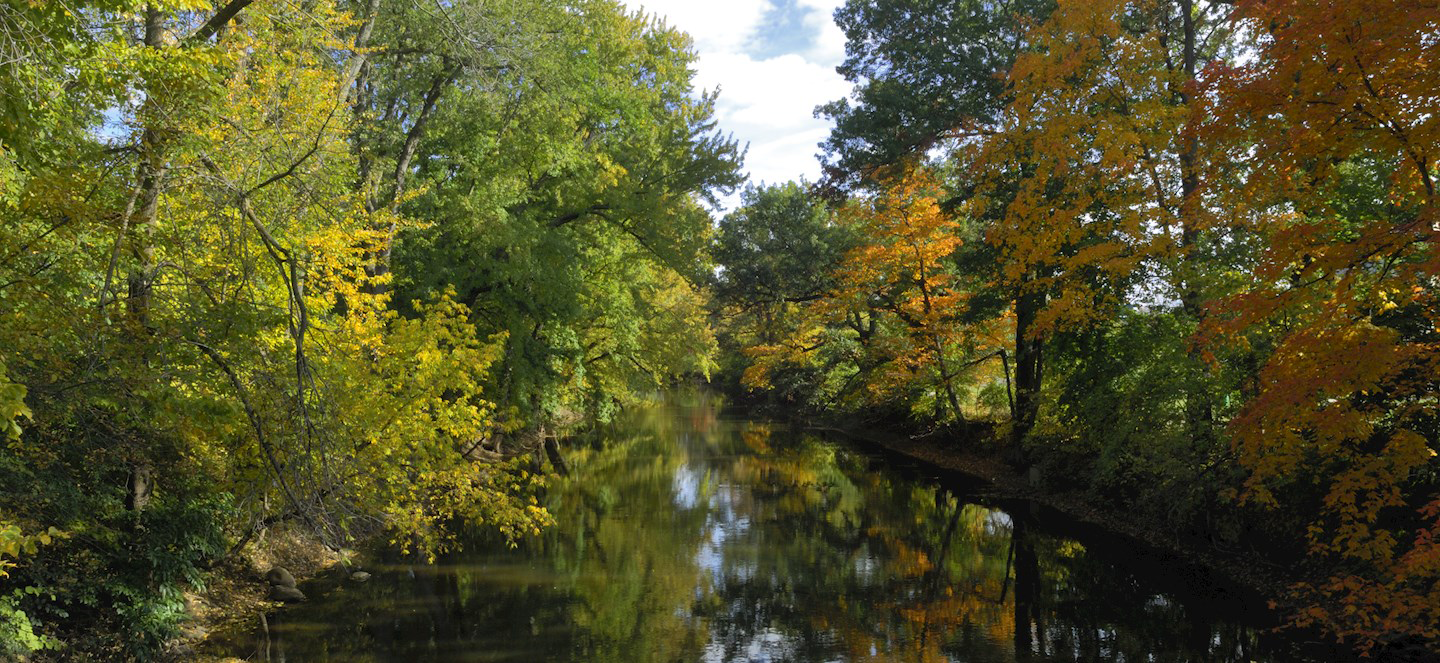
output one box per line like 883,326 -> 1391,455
958,0 -> 1230,453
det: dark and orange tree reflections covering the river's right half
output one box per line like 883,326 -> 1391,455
703,427 -> 1278,662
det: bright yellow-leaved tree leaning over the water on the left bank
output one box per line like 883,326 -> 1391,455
150,4 -> 549,553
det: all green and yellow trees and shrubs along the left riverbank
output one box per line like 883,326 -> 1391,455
0,0 -> 740,660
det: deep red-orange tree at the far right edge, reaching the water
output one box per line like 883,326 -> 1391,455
1204,0 -> 1440,646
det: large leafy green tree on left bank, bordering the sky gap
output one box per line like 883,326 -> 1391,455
380,1 -> 740,431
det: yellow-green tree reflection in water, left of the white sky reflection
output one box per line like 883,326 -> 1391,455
536,411 -> 714,662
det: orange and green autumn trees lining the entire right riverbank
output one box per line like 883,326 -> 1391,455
720,0 -> 1440,650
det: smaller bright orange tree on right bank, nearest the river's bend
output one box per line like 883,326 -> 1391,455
746,169 -> 1008,425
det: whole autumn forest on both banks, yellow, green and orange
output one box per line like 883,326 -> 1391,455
0,0 -> 1440,660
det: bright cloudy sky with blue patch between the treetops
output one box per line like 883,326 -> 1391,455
625,0 -> 850,208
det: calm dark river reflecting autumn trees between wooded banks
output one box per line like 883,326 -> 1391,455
210,396 -> 1324,663
